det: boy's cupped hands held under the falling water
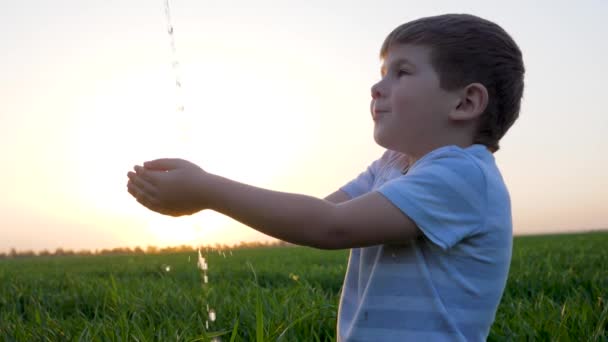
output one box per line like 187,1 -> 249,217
127,159 -> 208,216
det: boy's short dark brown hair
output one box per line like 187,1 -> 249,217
380,14 -> 525,152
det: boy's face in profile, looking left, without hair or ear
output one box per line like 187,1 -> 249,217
371,44 -> 458,157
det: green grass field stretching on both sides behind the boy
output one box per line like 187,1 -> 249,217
0,233 -> 608,341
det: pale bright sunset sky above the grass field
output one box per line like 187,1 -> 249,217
0,0 -> 608,252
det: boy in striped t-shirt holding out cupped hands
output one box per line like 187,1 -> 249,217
127,15 -> 524,341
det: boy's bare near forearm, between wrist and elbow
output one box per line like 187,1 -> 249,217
203,175 -> 336,248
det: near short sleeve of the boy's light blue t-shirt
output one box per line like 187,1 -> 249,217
378,151 -> 487,250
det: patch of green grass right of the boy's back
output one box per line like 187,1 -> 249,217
489,232 -> 608,341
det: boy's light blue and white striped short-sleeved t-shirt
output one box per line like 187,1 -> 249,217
338,145 -> 512,341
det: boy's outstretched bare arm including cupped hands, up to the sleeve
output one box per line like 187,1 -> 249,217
128,160 -> 419,249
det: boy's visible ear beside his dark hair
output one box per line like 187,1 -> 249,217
448,83 -> 488,121
